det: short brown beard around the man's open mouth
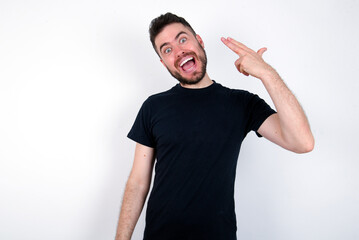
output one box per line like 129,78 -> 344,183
167,44 -> 207,85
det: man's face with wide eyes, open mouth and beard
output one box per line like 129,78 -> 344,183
155,23 -> 207,85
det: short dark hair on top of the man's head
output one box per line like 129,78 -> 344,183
149,12 -> 196,54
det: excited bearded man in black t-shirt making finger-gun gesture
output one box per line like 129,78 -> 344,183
116,13 -> 314,240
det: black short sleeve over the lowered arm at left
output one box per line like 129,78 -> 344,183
127,99 -> 155,148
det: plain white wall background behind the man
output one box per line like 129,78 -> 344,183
0,0 -> 359,240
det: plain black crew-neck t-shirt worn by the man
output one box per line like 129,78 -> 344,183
128,82 -> 275,240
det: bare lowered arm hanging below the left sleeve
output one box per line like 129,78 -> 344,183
115,143 -> 155,240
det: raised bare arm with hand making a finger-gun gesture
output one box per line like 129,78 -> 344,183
221,38 -> 314,153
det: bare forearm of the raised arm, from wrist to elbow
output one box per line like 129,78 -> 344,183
260,66 -> 314,152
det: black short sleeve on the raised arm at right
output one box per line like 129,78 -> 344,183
246,93 -> 276,137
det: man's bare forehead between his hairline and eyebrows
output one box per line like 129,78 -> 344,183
155,23 -> 193,48
